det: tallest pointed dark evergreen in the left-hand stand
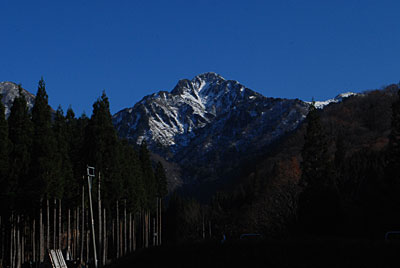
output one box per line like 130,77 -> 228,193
31,78 -> 59,203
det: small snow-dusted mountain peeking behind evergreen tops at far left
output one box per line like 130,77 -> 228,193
0,82 -> 35,117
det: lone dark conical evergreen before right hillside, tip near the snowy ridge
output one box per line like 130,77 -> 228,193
298,103 -> 341,234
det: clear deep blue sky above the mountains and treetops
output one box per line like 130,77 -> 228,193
0,0 -> 400,115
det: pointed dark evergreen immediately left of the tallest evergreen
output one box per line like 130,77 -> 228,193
4,86 -> 34,213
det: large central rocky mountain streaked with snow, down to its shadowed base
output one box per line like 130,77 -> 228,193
113,73 -> 309,195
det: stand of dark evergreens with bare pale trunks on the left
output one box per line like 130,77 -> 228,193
0,78 -> 167,268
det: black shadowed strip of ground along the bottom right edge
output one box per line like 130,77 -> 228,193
108,238 -> 400,268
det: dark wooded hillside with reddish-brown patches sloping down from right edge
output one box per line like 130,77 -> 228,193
162,85 -> 400,243
